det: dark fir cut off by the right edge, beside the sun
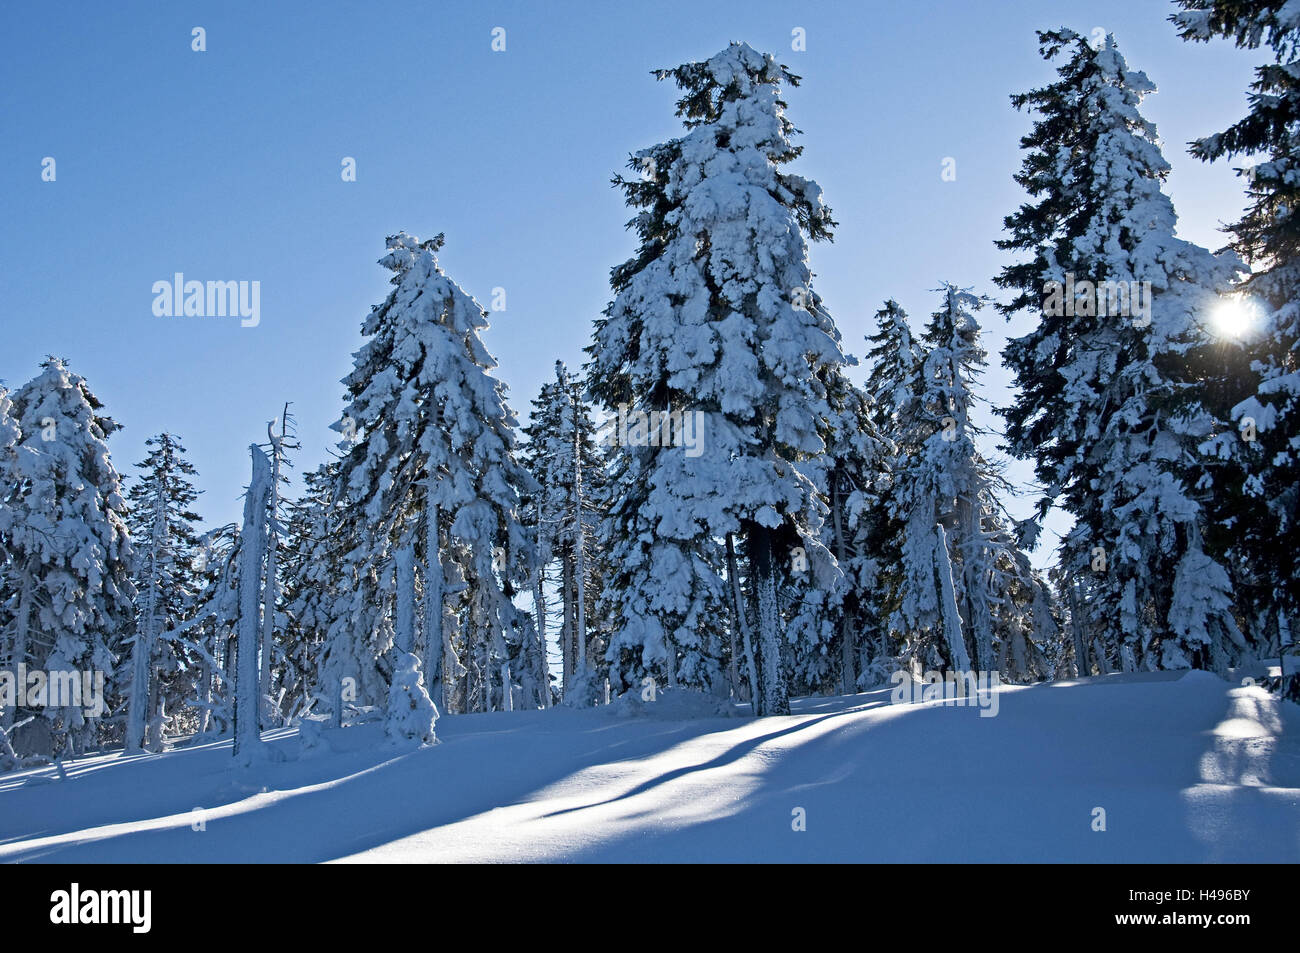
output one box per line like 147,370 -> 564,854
1173,0 -> 1300,671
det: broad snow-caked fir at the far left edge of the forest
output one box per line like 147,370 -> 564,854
0,358 -> 135,755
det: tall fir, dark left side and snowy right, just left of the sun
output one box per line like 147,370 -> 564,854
996,29 -> 1247,672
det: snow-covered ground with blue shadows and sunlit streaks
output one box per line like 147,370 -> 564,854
0,672 -> 1300,862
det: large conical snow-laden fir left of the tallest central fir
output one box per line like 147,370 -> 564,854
334,233 -> 536,710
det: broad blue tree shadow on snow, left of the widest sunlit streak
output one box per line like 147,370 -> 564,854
0,711 -> 769,863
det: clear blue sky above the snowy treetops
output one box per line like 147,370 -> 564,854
0,0 -> 1257,562
